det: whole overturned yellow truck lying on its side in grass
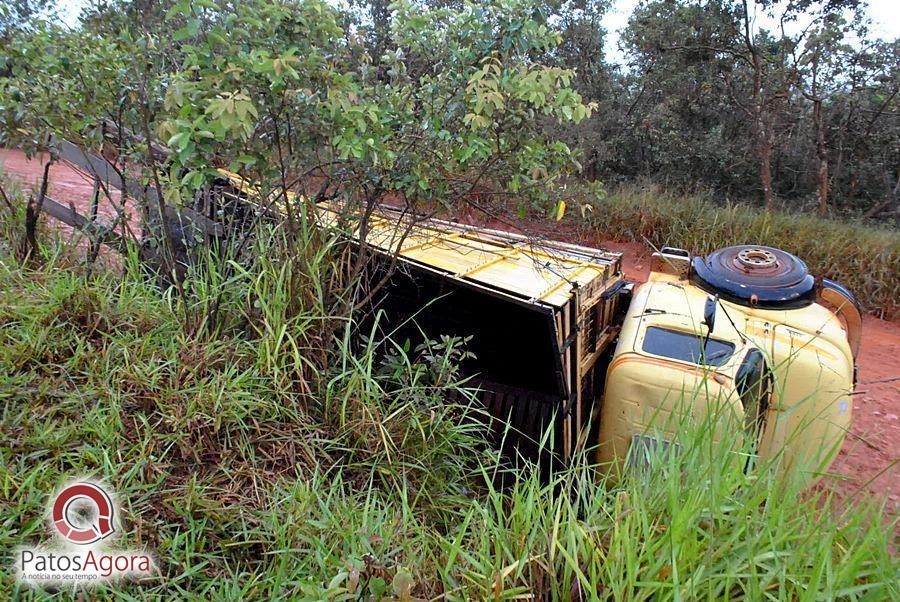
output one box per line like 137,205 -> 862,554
211,171 -> 861,483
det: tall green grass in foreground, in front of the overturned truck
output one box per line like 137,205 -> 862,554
0,175 -> 900,600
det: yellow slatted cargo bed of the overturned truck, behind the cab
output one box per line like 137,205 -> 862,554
342,208 -> 625,458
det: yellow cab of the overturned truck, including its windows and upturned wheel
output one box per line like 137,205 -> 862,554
598,246 -> 860,482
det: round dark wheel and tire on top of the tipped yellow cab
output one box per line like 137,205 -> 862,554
691,245 -> 816,309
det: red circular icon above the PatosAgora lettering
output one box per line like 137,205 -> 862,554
52,483 -> 115,545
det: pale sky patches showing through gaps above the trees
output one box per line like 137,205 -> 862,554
58,0 -> 900,62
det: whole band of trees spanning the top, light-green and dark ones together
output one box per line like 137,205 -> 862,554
0,0 -> 900,225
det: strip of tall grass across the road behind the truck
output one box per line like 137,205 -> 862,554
576,186 -> 900,317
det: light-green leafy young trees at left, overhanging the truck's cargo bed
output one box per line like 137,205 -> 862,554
0,0 -> 592,298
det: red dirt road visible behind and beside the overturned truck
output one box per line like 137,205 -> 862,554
0,149 -> 900,511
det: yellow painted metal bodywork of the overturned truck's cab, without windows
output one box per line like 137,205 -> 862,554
598,272 -> 853,484
